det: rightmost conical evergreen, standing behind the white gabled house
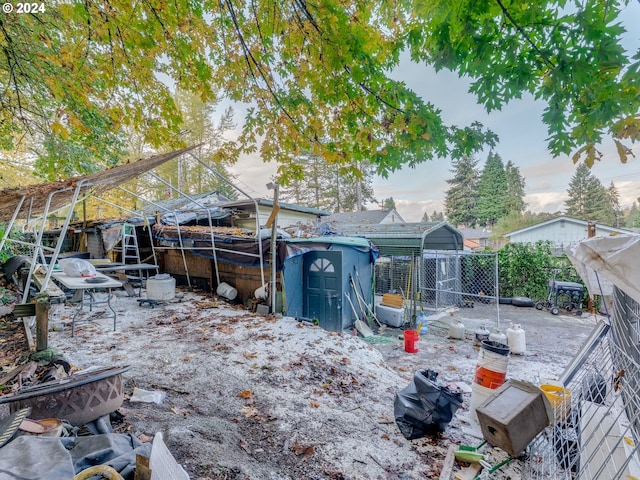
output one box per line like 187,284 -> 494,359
565,163 -> 616,225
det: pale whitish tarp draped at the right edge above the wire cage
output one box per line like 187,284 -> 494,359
565,234 -> 640,303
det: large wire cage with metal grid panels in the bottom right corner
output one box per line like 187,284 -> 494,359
523,288 -> 640,480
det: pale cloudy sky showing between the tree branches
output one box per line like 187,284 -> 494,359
230,2 -> 640,222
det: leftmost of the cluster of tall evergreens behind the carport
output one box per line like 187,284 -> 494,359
444,156 -> 479,227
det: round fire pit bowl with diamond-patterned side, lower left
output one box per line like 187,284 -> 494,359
0,365 -> 131,426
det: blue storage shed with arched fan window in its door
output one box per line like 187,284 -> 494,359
281,236 -> 376,332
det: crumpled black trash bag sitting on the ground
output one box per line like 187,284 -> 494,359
394,370 -> 462,440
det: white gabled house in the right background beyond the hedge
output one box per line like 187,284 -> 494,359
505,216 -> 629,251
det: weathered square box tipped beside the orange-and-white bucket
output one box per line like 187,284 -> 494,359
476,380 -> 553,456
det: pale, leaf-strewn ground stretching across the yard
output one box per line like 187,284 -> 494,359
3,291 -> 599,480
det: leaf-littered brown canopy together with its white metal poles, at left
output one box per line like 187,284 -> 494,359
0,145 -> 197,301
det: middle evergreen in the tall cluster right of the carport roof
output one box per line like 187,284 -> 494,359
477,152 -> 507,226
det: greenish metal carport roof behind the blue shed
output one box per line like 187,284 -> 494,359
340,222 -> 464,255
